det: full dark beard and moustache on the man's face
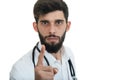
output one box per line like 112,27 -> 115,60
38,31 -> 66,53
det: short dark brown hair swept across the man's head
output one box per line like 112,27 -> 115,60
33,0 -> 69,22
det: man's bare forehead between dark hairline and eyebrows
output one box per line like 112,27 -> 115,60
39,11 -> 65,21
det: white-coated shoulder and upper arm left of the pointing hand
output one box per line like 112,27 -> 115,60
10,51 -> 34,80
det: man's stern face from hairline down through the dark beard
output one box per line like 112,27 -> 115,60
33,11 -> 70,53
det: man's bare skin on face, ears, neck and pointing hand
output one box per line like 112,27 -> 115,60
33,10 -> 71,80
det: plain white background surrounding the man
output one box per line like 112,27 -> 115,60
0,0 -> 120,80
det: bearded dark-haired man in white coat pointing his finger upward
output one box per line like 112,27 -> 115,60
10,0 -> 76,80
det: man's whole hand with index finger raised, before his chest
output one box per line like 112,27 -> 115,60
35,45 -> 57,80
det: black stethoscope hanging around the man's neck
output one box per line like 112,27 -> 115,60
32,42 -> 77,80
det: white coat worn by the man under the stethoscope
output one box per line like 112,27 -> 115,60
10,43 -> 75,80
